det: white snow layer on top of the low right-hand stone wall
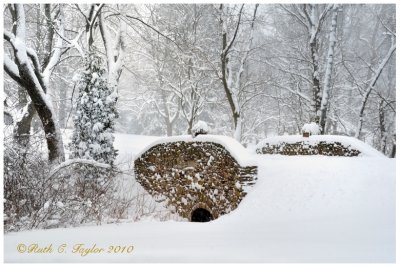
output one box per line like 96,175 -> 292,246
256,135 -> 385,157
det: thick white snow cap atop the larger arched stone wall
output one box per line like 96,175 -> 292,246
134,135 -> 257,166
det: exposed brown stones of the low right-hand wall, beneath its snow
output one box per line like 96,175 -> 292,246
256,141 -> 360,157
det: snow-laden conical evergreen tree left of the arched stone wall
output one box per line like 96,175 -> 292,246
71,53 -> 118,164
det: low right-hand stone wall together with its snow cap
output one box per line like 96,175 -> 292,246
256,135 -> 384,157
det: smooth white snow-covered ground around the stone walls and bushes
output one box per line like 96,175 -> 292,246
4,134 -> 395,263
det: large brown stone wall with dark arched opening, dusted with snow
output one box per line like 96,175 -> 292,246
135,136 -> 257,221
